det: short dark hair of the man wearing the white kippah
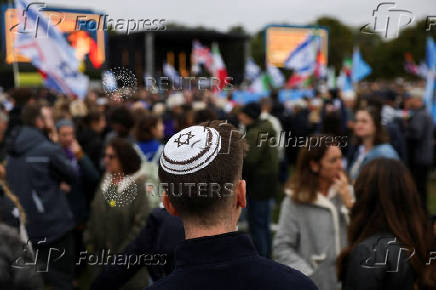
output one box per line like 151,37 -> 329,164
159,120 -> 244,226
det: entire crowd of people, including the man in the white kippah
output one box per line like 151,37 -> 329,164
0,83 -> 436,290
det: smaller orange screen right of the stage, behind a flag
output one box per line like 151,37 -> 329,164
265,25 -> 328,67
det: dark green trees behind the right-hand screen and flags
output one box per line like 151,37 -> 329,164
250,16 -> 436,80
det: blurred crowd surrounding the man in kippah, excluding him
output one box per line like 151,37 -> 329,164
0,82 -> 436,289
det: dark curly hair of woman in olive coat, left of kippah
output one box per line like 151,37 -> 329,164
107,137 -> 141,175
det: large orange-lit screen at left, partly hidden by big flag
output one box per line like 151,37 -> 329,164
2,6 -> 106,68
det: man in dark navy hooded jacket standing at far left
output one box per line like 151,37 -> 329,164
5,104 -> 77,290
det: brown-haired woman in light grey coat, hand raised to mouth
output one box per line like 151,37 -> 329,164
273,136 -> 353,290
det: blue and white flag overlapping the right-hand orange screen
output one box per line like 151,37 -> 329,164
284,34 -> 321,76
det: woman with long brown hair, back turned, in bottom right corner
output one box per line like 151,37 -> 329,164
338,158 -> 436,290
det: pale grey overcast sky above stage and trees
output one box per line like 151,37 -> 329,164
45,0 -> 436,32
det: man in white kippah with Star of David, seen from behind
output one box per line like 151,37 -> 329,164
147,121 -> 317,290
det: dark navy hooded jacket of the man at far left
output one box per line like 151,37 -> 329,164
6,127 -> 77,243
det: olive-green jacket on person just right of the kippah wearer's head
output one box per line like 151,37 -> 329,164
242,119 -> 279,200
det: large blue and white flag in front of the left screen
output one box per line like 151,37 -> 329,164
14,0 -> 89,98
